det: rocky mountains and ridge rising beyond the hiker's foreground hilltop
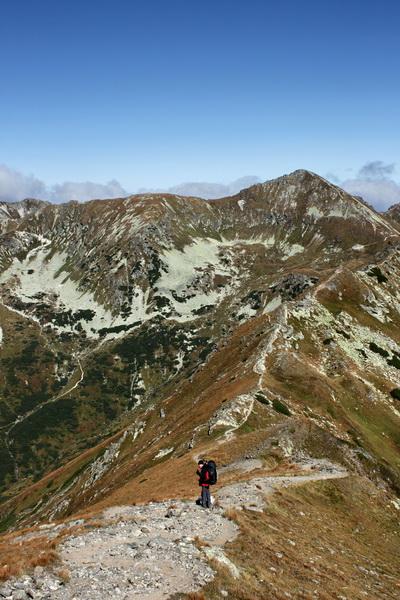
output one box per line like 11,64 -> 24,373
0,171 -> 400,529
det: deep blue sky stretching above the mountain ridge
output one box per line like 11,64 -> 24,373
0,0 -> 400,206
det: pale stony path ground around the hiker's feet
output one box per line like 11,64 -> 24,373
0,459 -> 348,600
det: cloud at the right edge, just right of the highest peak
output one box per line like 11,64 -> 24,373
341,160 -> 400,211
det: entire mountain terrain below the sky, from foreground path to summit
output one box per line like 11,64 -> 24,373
0,171 -> 400,600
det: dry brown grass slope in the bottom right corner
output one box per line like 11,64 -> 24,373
198,477 -> 400,600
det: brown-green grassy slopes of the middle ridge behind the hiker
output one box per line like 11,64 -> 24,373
3,253 -> 399,516
